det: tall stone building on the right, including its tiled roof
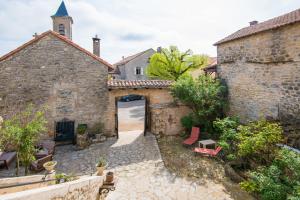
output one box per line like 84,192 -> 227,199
215,9 -> 300,142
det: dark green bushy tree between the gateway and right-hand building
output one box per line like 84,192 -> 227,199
171,75 -> 227,131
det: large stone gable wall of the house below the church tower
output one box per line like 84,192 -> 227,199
0,34 -> 108,137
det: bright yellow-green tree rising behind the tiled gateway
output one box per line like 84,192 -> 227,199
146,46 -> 208,81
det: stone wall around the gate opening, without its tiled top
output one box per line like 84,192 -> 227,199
106,88 -> 190,135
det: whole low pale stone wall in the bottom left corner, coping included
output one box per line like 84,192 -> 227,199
0,176 -> 103,200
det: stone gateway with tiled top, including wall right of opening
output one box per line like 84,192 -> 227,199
105,80 -> 190,136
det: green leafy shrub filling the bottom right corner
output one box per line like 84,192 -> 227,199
240,149 -> 300,200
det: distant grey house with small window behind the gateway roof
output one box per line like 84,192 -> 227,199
110,49 -> 155,80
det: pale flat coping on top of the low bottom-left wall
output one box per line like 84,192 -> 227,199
0,176 -> 103,200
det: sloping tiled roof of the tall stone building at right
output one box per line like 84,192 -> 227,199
214,9 -> 300,45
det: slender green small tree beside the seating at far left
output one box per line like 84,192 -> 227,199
0,104 -> 47,175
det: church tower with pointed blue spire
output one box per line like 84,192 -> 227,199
51,1 -> 73,40
